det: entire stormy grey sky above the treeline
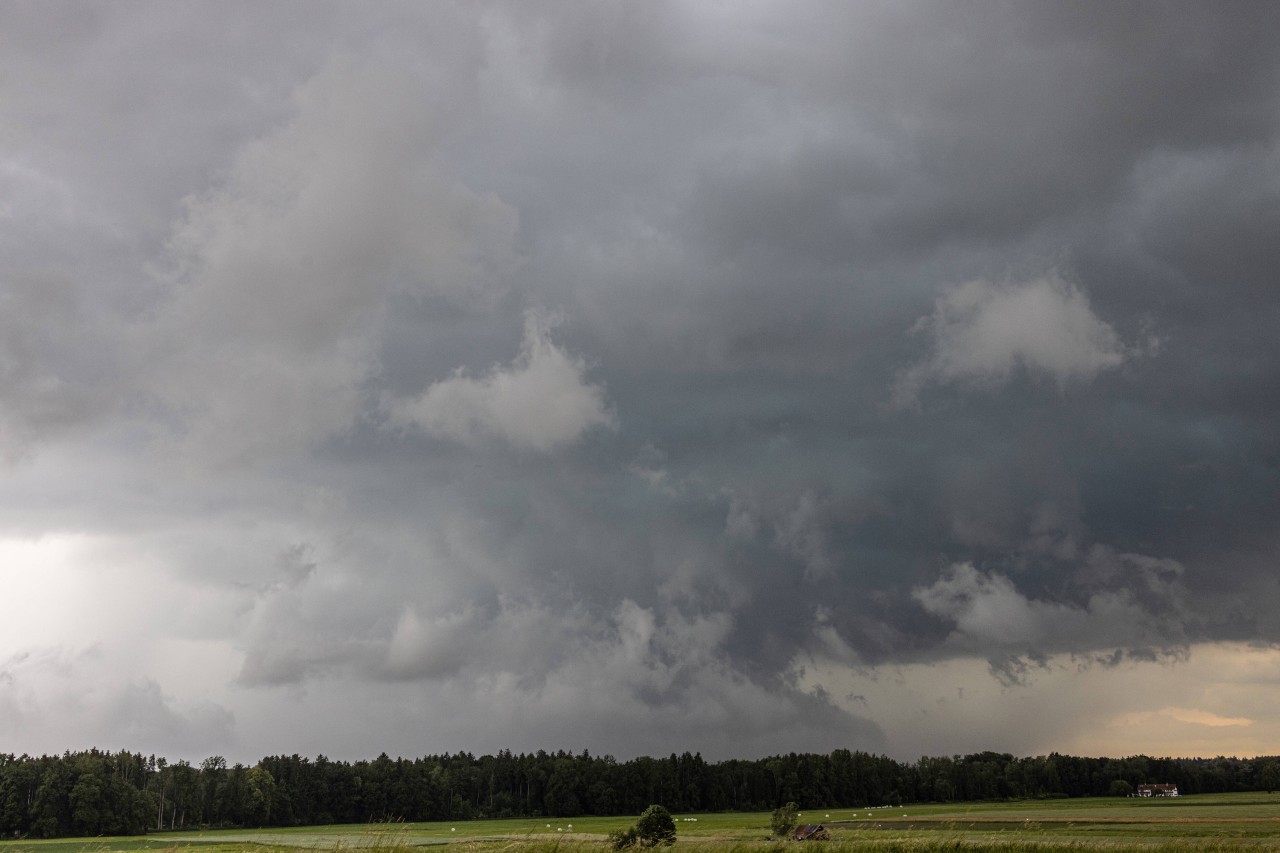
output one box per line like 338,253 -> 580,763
0,0 -> 1280,763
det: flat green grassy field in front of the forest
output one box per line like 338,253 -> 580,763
0,794 -> 1280,853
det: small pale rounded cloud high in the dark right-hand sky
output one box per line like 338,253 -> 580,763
893,274 -> 1133,405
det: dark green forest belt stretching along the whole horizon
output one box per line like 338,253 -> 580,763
0,749 -> 1280,838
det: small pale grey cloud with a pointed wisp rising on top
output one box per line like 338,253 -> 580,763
390,311 -> 616,451
